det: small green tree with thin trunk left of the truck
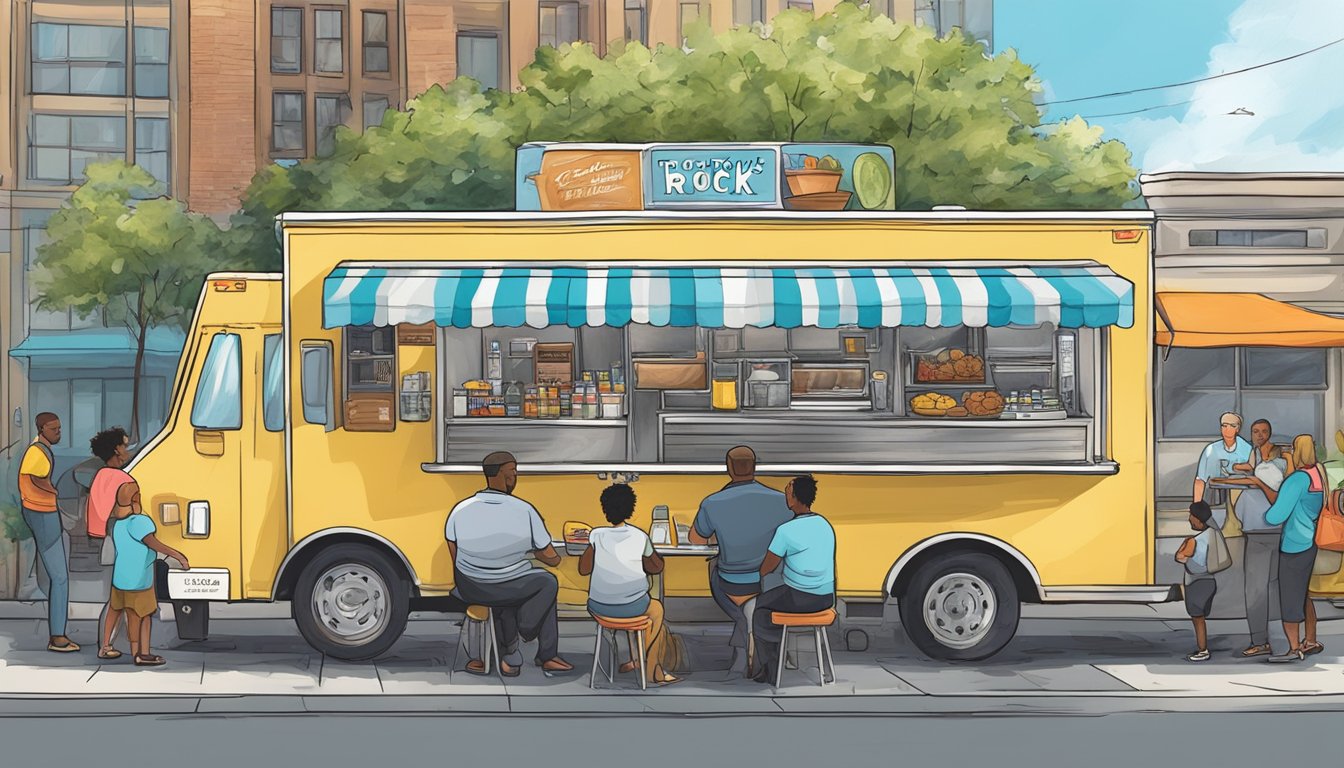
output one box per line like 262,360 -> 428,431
34,160 -> 220,436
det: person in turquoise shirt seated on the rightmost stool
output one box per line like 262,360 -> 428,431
751,475 -> 836,683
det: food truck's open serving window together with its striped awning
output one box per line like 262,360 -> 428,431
324,265 -> 1133,467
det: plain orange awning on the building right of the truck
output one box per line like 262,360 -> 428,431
1156,293 -> 1344,348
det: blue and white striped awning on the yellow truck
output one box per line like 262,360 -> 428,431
323,265 -> 1134,328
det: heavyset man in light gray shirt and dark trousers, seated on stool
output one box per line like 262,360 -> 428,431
444,451 -> 574,678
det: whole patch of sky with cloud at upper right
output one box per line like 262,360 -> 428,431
995,0 -> 1344,171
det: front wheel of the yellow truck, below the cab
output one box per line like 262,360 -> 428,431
290,543 -> 411,662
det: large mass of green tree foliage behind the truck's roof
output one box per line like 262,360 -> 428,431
234,3 -> 1136,265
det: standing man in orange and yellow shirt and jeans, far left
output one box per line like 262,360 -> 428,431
19,412 -> 79,654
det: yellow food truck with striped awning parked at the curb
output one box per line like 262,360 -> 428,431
130,143 -> 1173,659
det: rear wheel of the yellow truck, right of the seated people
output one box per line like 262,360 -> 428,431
898,551 -> 1021,662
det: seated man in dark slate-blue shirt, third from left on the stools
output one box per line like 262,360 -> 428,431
691,445 -> 790,675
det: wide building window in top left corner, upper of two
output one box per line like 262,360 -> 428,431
31,23 -> 126,95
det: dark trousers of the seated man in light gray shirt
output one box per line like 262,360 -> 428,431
453,570 -> 560,664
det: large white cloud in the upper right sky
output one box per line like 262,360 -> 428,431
1107,0 -> 1344,172
